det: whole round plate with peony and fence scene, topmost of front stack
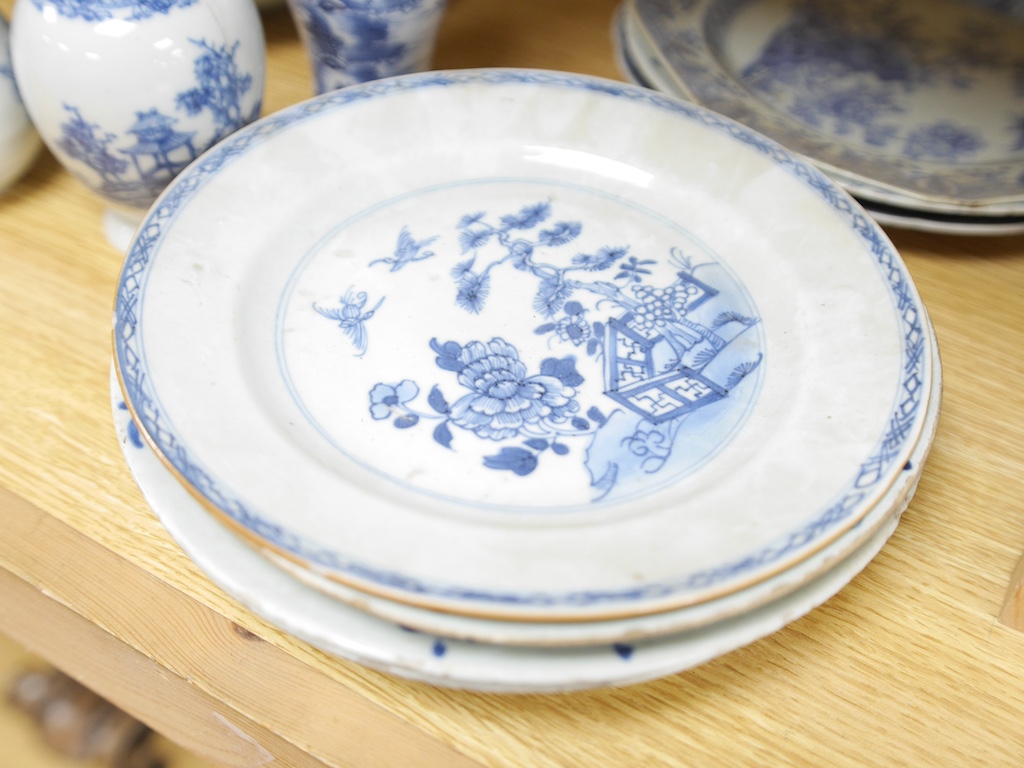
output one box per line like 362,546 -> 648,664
114,70 -> 933,621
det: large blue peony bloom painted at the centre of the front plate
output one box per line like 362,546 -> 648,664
451,338 -> 580,440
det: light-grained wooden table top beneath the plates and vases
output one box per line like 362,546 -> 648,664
0,0 -> 1024,768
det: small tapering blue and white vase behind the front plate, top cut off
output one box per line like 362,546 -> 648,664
288,0 -> 445,93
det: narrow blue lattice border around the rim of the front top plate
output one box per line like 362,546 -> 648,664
114,69 -> 928,608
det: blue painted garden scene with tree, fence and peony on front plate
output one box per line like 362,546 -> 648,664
358,201 -> 761,489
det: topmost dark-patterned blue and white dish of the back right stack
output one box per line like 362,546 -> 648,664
627,0 -> 1024,216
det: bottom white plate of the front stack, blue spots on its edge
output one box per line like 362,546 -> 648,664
111,360 -> 937,693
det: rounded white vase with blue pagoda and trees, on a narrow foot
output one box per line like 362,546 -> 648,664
10,0 -> 266,245
